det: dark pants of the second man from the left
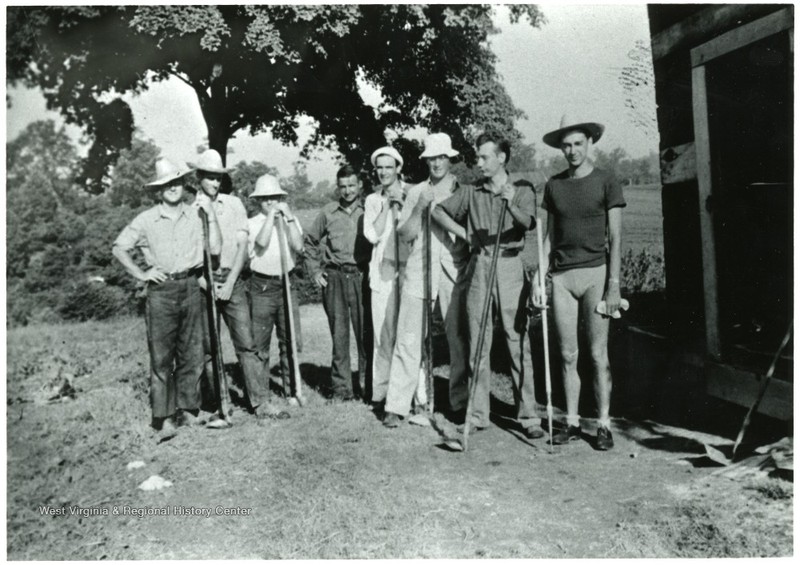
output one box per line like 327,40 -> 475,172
202,278 -> 268,408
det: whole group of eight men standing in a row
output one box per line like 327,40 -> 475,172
114,116 -> 625,450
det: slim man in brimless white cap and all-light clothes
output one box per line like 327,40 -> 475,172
364,146 -> 408,413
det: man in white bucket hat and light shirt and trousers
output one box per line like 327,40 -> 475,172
383,133 -> 469,428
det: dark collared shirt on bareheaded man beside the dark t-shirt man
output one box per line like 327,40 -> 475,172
439,179 -> 536,253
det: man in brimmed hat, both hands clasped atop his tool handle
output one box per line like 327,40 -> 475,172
247,175 -> 303,419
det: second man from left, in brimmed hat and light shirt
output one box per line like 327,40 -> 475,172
192,149 -> 264,418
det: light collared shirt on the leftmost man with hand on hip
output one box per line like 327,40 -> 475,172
114,203 -> 203,274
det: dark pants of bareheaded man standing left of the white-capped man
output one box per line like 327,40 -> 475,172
322,269 -> 368,397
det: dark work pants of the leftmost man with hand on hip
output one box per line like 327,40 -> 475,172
145,277 -> 203,418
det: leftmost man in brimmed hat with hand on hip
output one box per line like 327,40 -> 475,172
112,159 -> 221,437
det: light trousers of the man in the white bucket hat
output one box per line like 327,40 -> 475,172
386,264 -> 469,416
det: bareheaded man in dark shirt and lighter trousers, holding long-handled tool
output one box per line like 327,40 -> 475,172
433,132 -> 544,439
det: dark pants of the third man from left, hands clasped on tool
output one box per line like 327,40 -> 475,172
248,276 -> 291,401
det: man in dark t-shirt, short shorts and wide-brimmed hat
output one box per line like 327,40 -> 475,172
534,116 -> 625,451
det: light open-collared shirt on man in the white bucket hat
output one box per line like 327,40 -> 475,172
399,175 -> 469,298
